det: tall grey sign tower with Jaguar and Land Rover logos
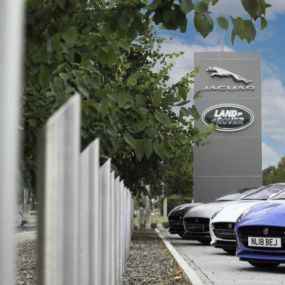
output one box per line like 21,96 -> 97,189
194,52 -> 262,202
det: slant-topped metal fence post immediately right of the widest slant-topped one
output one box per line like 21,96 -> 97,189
79,139 -> 101,285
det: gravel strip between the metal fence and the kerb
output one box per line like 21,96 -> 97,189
123,233 -> 189,285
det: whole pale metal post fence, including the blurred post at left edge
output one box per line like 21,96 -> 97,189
0,3 -> 133,285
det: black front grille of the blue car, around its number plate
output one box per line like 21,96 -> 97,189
238,226 -> 285,250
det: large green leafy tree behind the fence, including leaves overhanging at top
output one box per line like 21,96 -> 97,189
23,0 -> 268,194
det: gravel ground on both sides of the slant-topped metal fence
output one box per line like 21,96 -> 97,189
15,232 -> 189,285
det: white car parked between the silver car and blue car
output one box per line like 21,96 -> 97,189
210,183 -> 285,254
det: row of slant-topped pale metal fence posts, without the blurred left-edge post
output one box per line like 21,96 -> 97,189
38,95 -> 132,285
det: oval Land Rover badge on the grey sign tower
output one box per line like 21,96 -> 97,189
202,104 -> 254,132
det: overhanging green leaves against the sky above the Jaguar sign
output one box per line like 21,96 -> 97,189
148,0 -> 271,43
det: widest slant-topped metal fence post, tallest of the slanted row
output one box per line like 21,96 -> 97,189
38,95 -> 80,285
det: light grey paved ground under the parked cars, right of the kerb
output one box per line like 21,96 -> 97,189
161,232 -> 285,285
